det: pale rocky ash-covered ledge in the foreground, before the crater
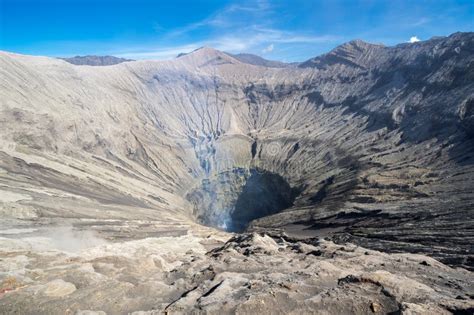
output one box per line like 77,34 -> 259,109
0,221 -> 474,314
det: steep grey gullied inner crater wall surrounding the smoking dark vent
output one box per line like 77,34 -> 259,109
0,33 -> 474,274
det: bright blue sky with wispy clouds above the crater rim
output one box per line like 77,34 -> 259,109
0,0 -> 474,61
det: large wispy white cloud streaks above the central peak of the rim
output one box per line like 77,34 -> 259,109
113,0 -> 342,59
